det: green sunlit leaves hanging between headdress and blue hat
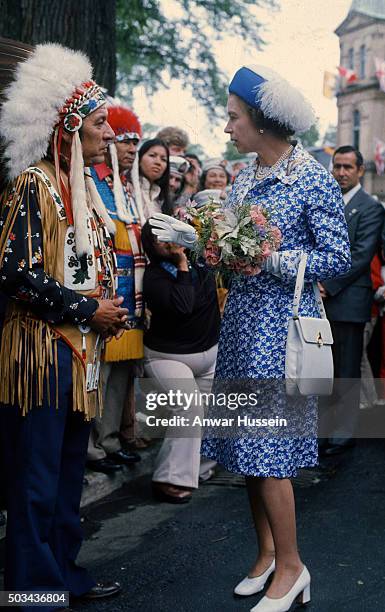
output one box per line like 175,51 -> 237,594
117,0 -> 277,120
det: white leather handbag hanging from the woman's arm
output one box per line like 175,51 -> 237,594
285,253 -> 334,395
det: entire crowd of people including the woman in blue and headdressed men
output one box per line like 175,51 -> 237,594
0,35 -> 385,612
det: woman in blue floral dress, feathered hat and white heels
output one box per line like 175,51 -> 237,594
150,66 -> 350,612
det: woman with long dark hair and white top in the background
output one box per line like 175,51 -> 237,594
132,138 -> 172,222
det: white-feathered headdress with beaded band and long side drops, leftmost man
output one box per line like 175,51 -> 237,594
0,39 -> 106,257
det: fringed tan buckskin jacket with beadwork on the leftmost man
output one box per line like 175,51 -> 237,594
0,161 -> 115,420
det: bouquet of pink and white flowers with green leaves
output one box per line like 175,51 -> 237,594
185,202 -> 281,275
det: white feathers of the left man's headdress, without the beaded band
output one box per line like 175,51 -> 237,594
0,43 -> 92,180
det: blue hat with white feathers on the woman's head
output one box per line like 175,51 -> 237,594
229,66 -> 315,133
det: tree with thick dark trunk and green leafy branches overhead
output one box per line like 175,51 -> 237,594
0,0 -> 279,120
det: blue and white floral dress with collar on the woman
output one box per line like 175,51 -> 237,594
202,144 -> 350,478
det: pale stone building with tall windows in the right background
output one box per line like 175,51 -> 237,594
335,0 -> 385,196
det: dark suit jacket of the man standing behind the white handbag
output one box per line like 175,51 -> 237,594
323,188 -> 385,323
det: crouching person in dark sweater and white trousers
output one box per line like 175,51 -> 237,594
142,223 -> 220,503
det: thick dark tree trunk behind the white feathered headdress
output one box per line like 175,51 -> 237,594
0,0 -> 116,95
